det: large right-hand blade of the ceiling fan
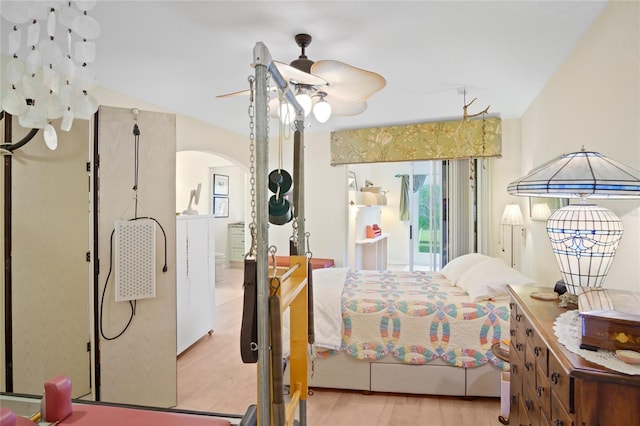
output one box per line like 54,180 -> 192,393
311,60 -> 387,102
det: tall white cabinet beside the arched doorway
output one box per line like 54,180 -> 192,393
176,215 -> 216,354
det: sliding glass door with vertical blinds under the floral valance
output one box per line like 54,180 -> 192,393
348,160 -> 487,271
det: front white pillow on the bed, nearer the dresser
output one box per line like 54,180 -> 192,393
456,258 -> 535,302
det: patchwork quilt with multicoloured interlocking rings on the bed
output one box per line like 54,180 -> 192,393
314,268 -> 509,369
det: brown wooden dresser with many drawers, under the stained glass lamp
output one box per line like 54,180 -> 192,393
509,286 -> 640,426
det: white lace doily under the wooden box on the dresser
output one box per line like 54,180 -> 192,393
553,309 -> 640,375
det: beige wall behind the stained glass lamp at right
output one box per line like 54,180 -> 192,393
520,1 -> 640,290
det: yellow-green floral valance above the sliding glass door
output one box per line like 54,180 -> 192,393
331,117 -> 502,166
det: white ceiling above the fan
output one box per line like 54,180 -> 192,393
3,1 -> 606,133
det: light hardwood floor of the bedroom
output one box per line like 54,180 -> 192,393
176,268 -> 500,426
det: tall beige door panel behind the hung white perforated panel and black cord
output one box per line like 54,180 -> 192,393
95,106 -> 177,407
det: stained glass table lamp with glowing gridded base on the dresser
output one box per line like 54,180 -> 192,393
507,148 -> 640,295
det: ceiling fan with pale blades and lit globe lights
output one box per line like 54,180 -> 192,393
218,34 -> 387,123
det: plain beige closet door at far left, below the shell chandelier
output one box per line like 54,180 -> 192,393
3,117 -> 91,397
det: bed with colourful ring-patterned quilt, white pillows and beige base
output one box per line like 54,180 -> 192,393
300,253 -> 533,396
